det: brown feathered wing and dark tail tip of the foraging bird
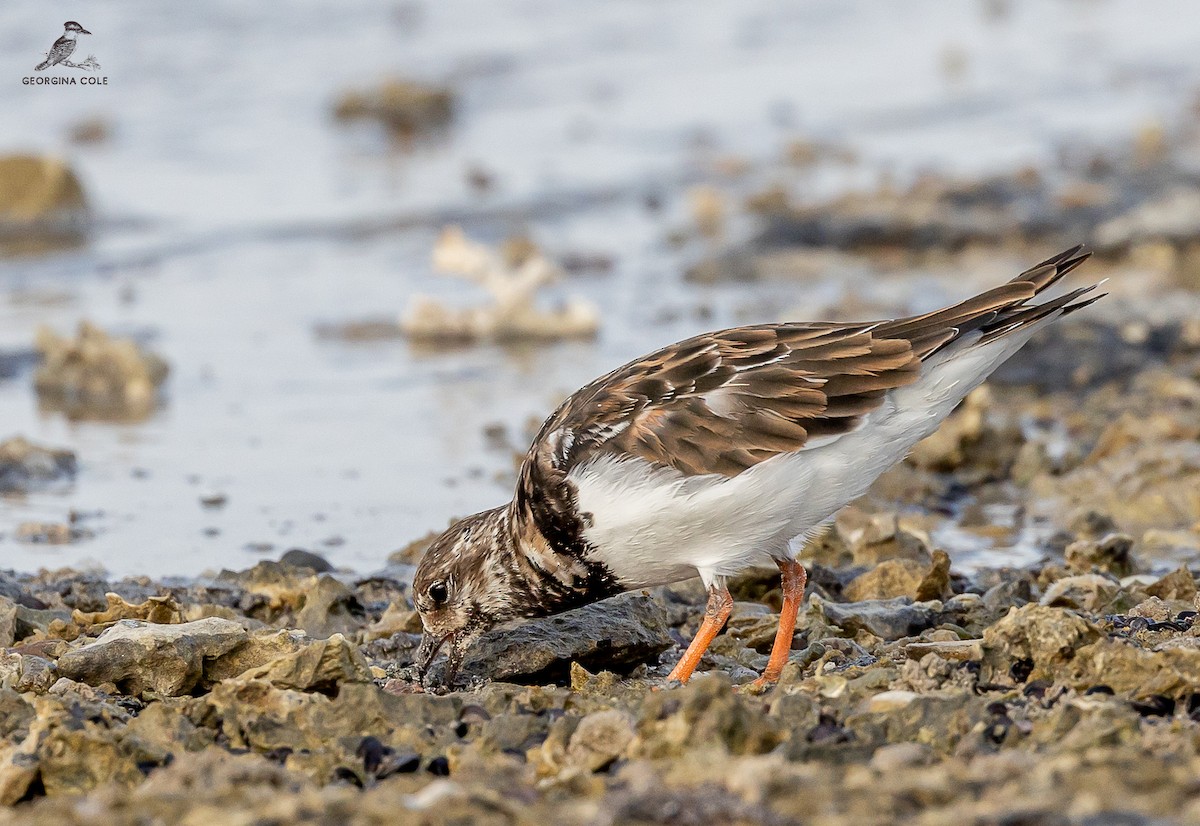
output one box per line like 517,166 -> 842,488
522,247 -> 1094,487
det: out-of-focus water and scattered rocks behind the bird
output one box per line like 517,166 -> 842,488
0,0 -> 1200,575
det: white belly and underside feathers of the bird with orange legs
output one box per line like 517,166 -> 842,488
568,321 -> 1032,588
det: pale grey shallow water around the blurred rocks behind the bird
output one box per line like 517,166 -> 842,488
0,0 -> 1200,575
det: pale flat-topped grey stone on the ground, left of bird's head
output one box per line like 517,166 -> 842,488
59,617 -> 247,696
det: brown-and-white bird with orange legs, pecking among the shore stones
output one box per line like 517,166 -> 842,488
412,245 -> 1104,690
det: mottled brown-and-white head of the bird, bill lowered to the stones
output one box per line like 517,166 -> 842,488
413,508 -> 517,684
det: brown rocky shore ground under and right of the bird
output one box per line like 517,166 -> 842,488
0,312 -> 1200,825
